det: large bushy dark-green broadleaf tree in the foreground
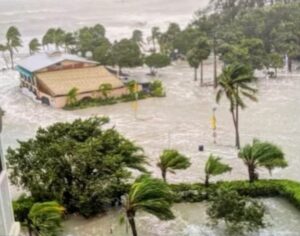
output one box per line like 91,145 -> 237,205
7,117 -> 145,216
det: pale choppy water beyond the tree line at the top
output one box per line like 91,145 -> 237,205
0,0 -> 209,42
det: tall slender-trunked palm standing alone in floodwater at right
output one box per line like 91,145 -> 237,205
216,64 -> 257,149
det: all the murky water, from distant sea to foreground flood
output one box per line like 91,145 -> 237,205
0,0 -> 300,236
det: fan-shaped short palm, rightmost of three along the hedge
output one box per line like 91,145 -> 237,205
239,139 -> 287,182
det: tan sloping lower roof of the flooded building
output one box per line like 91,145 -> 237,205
36,66 -> 124,96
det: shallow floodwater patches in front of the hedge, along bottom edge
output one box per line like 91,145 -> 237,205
64,198 -> 300,236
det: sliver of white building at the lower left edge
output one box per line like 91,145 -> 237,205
0,108 -> 20,236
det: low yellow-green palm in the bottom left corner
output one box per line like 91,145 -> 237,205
28,202 -> 64,236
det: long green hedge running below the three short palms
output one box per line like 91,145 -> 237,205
170,180 -> 300,210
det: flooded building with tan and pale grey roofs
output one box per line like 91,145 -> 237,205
16,52 -> 128,108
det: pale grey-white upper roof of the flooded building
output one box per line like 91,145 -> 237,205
17,52 -> 98,72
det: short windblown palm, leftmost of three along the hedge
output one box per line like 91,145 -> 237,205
157,150 -> 191,182
